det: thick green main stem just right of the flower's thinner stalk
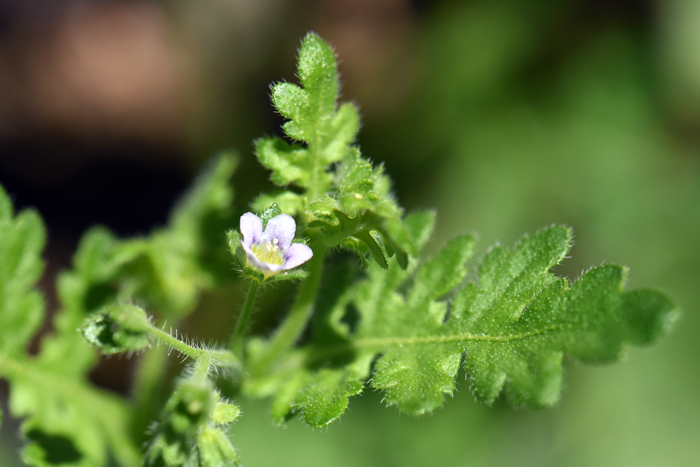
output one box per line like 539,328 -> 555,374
251,244 -> 326,374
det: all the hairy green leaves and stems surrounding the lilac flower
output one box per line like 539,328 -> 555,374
0,34 -> 676,467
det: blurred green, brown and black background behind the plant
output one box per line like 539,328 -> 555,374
0,0 -> 700,467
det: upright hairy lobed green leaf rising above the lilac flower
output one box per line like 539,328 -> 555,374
260,34 -> 416,268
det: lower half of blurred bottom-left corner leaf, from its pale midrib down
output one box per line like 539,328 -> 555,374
6,364 -> 140,467
